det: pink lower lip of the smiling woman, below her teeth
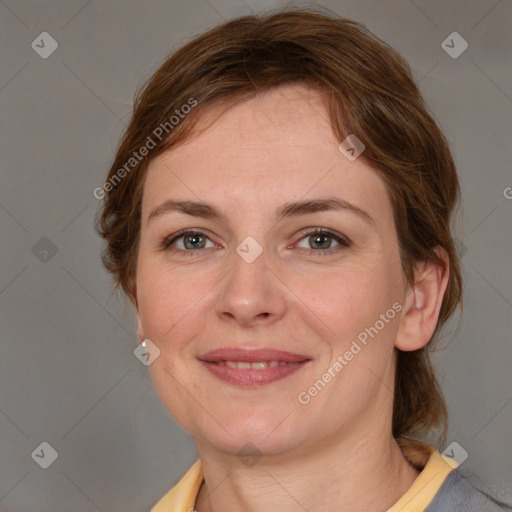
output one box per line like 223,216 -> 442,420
201,361 -> 308,386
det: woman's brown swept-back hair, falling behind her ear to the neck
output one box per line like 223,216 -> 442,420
97,9 -> 462,448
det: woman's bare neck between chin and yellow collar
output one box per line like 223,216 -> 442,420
195,425 -> 419,512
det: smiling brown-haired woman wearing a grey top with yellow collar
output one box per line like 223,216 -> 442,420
99,10 -> 508,512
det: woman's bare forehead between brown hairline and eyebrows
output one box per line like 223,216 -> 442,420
143,85 -> 389,223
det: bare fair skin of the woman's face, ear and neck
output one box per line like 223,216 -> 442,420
134,85 -> 448,512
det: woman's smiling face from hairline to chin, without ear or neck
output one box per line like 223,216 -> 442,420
136,85 -> 406,460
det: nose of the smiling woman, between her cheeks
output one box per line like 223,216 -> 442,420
216,241 -> 286,327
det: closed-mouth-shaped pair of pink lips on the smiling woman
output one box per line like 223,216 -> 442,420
197,348 -> 311,386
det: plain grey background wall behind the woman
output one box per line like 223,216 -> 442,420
0,0 -> 512,512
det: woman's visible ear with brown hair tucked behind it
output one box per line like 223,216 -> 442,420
395,247 -> 449,351
